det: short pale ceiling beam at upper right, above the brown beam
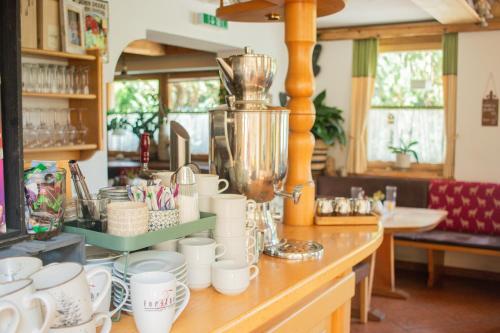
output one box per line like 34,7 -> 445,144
412,0 -> 481,24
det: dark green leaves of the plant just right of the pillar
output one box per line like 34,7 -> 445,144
311,90 -> 346,146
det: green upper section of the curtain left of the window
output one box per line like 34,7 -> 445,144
352,38 -> 378,77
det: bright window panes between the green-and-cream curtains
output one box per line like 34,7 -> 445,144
367,50 -> 445,164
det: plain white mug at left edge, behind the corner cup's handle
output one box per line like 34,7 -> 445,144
0,279 -> 56,333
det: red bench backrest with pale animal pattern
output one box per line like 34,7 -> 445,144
428,180 -> 500,235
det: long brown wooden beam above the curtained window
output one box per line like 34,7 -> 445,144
318,18 -> 500,41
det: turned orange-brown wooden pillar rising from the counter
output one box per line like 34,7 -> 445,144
284,0 -> 316,225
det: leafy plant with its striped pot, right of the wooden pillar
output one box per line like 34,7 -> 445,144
311,90 -> 346,171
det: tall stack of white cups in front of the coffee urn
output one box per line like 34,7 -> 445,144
210,194 -> 256,263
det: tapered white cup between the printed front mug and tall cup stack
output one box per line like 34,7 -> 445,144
179,237 -> 224,289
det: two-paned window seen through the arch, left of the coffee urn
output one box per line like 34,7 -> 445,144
108,72 -> 220,155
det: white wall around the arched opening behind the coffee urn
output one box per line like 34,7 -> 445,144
81,0 -> 288,191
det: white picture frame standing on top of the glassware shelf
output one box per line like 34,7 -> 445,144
60,0 -> 85,53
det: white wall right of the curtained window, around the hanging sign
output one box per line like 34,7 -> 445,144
455,31 -> 500,183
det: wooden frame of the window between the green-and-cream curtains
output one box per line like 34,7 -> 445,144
365,35 -> 444,179
